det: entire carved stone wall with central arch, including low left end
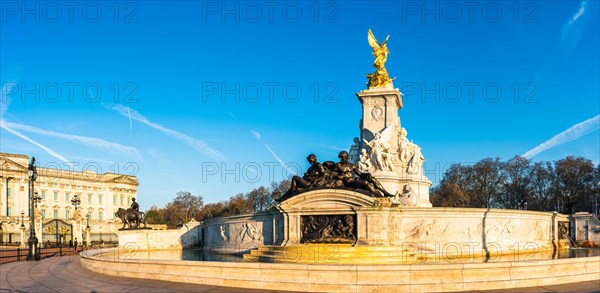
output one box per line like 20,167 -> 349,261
119,189 -> 569,258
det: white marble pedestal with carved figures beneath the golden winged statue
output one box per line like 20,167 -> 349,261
356,85 -> 431,207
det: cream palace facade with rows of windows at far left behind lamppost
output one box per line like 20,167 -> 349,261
0,153 -> 139,244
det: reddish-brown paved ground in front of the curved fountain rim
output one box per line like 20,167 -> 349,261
0,255 -> 600,293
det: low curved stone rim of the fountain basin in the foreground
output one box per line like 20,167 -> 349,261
81,246 -> 600,292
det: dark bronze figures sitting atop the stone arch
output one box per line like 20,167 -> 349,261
275,151 -> 394,202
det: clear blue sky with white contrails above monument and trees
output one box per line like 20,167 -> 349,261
0,1 -> 600,208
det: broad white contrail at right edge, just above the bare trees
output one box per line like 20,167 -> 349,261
522,114 -> 600,159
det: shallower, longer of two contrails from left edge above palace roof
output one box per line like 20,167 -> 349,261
2,121 -> 141,158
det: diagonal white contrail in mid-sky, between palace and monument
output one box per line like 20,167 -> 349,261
112,104 -> 226,161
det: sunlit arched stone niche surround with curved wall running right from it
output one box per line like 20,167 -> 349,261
276,190 -> 569,255
